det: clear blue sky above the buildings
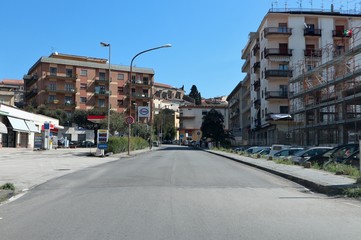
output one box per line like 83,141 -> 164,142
0,0 -> 354,98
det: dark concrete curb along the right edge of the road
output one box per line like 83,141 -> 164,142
204,150 -> 359,196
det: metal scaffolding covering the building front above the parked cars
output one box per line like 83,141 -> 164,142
289,27 -> 361,146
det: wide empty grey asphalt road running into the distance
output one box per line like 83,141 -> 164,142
0,146 -> 361,240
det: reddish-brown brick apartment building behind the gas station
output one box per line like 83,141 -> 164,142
24,53 -> 154,120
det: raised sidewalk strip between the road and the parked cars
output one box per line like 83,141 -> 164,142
205,150 -> 357,195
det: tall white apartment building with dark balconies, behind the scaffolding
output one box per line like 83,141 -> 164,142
242,9 -> 361,145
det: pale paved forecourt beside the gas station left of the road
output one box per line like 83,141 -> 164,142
0,148 -> 149,201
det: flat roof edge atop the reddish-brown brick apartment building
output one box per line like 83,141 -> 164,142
28,54 -> 154,74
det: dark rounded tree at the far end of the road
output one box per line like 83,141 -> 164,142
201,109 -> 225,144
